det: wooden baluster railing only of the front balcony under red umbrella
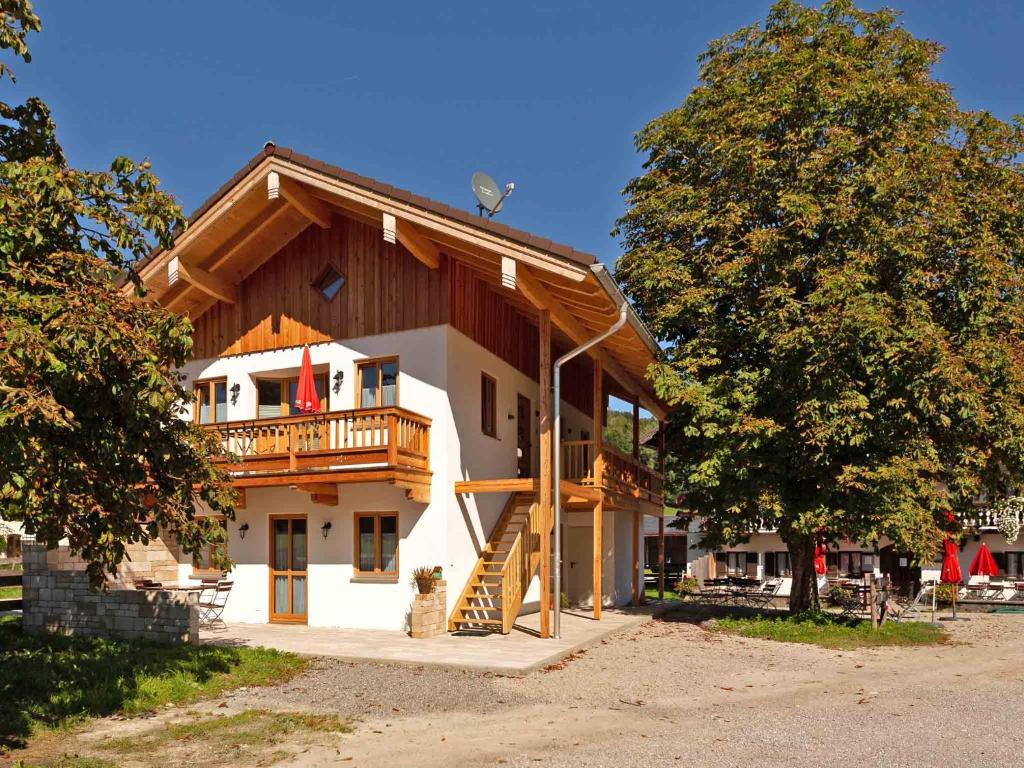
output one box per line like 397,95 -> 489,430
203,408 -> 430,472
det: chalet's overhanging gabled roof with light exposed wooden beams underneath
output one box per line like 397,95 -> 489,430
125,145 -> 667,419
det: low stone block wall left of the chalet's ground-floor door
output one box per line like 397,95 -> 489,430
22,544 -> 199,643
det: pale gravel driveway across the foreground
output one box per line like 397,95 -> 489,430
211,614 -> 1024,768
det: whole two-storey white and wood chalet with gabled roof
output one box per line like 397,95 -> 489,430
128,144 -> 666,635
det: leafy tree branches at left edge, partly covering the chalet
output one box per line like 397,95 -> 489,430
0,0 -> 233,583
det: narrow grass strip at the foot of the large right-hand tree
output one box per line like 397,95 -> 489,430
711,613 -> 946,650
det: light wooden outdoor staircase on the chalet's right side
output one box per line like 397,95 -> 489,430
449,493 -> 541,635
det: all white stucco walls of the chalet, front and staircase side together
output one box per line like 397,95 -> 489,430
179,326 -> 632,630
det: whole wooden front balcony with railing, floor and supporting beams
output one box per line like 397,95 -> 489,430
203,408 -> 430,501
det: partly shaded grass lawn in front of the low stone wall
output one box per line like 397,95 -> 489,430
0,617 -> 306,754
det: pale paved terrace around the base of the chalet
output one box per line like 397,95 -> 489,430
200,601 -> 678,675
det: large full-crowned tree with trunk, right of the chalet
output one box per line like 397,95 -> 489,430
615,0 -> 1024,610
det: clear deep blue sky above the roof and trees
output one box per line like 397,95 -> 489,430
4,0 -> 1024,261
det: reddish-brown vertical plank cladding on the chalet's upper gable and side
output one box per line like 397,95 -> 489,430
193,213 -> 593,413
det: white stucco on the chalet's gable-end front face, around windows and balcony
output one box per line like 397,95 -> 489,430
180,326 -> 453,630
